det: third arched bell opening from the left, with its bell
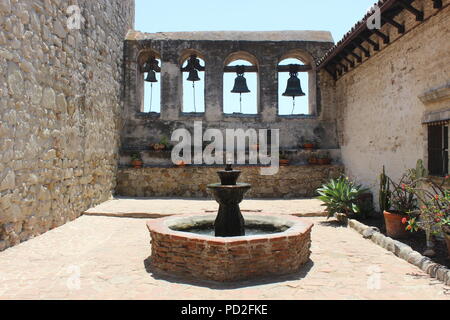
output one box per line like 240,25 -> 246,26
223,52 -> 259,114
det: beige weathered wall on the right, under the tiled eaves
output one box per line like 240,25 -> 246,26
334,0 -> 450,205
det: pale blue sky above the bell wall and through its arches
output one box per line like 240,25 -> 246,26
135,0 -> 375,114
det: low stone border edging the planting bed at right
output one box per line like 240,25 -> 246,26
339,219 -> 450,285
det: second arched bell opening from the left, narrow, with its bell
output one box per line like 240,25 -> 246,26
181,51 -> 205,113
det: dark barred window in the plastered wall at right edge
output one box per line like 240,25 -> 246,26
428,121 -> 449,176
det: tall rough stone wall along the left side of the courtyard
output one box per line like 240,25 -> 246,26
0,0 -> 134,251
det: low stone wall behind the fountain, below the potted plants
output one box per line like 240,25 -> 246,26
116,165 -> 344,199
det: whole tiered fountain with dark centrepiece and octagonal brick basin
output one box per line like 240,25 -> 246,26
147,165 -> 313,282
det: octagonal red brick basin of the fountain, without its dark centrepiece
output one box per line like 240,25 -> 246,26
147,214 -> 313,282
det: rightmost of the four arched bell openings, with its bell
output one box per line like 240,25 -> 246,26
278,58 -> 311,116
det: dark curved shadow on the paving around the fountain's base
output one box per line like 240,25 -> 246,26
144,257 -> 314,290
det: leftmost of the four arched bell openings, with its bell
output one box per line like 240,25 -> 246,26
137,50 -> 161,114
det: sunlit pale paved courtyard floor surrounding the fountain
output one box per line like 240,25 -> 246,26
0,200 -> 450,300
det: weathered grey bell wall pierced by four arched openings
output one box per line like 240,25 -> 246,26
120,31 -> 338,166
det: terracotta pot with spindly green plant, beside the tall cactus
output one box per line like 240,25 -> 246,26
380,168 -> 417,238
